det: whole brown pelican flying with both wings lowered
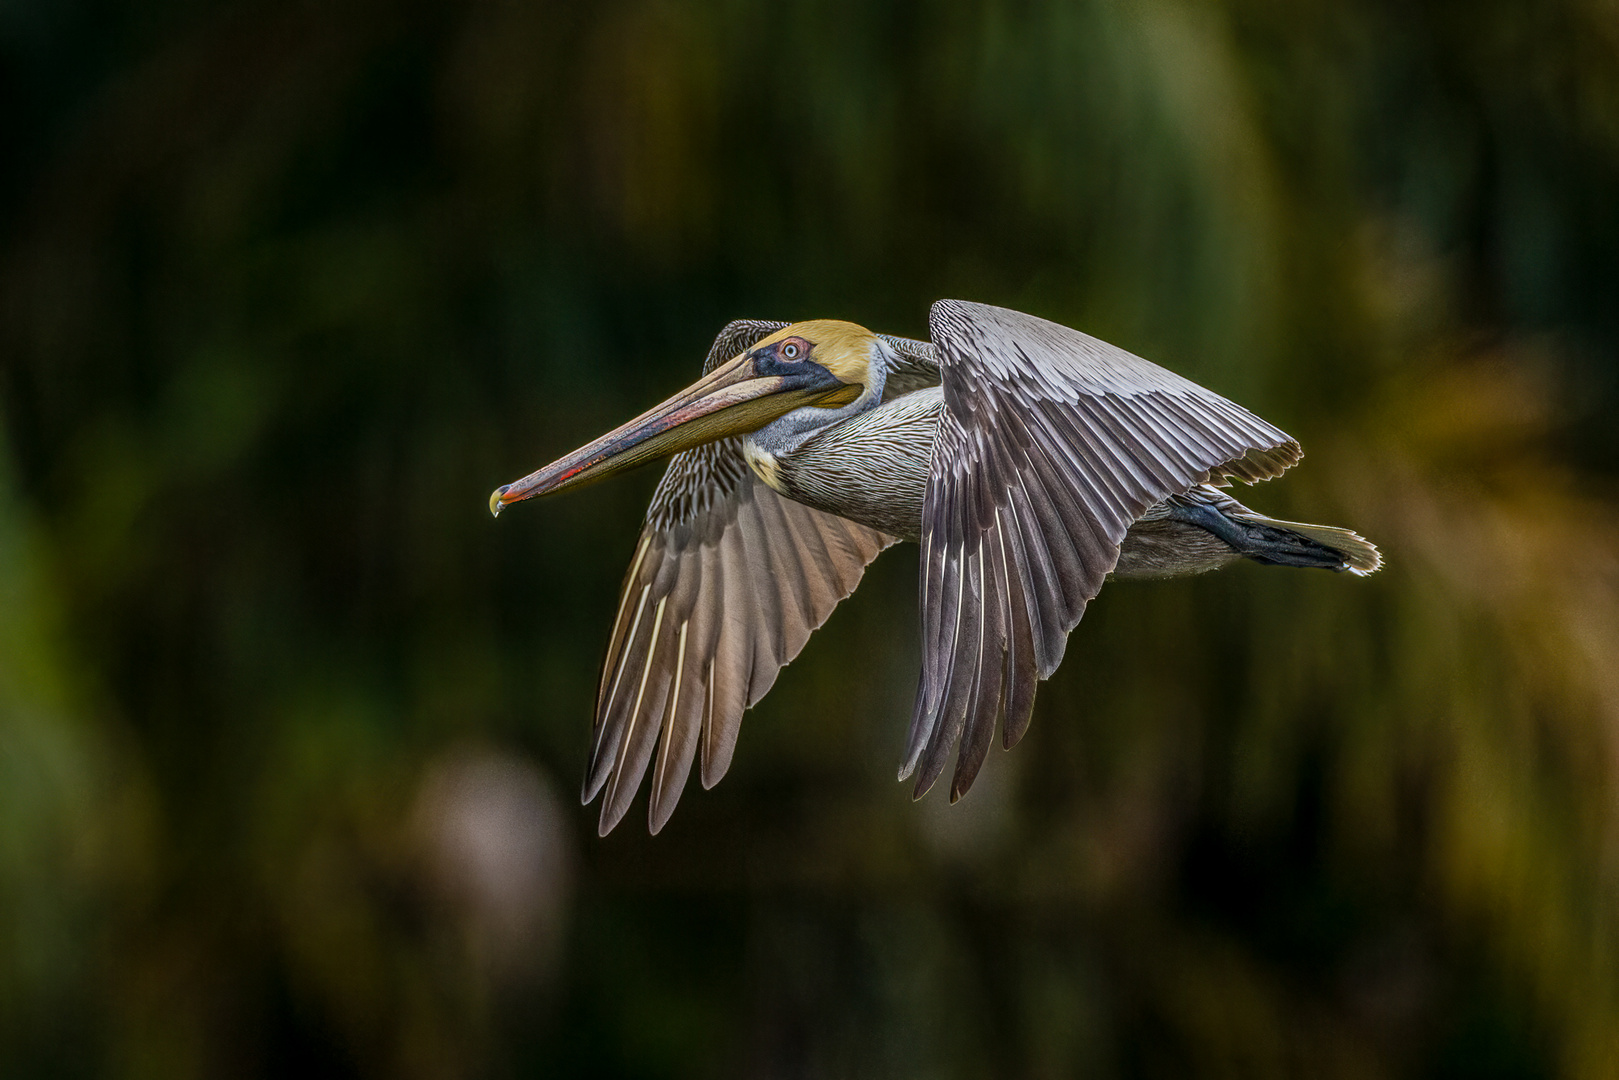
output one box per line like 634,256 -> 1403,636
489,300 -> 1381,836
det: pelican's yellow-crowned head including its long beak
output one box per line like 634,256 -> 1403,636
489,319 -> 884,515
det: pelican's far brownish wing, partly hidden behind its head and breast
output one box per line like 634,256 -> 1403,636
583,321 -> 894,836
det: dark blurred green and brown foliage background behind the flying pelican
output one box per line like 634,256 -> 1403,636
0,0 -> 1619,1078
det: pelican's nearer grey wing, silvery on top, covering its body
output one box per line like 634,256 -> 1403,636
900,300 -> 1300,801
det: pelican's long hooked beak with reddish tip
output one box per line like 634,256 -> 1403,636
489,351 -> 865,517
